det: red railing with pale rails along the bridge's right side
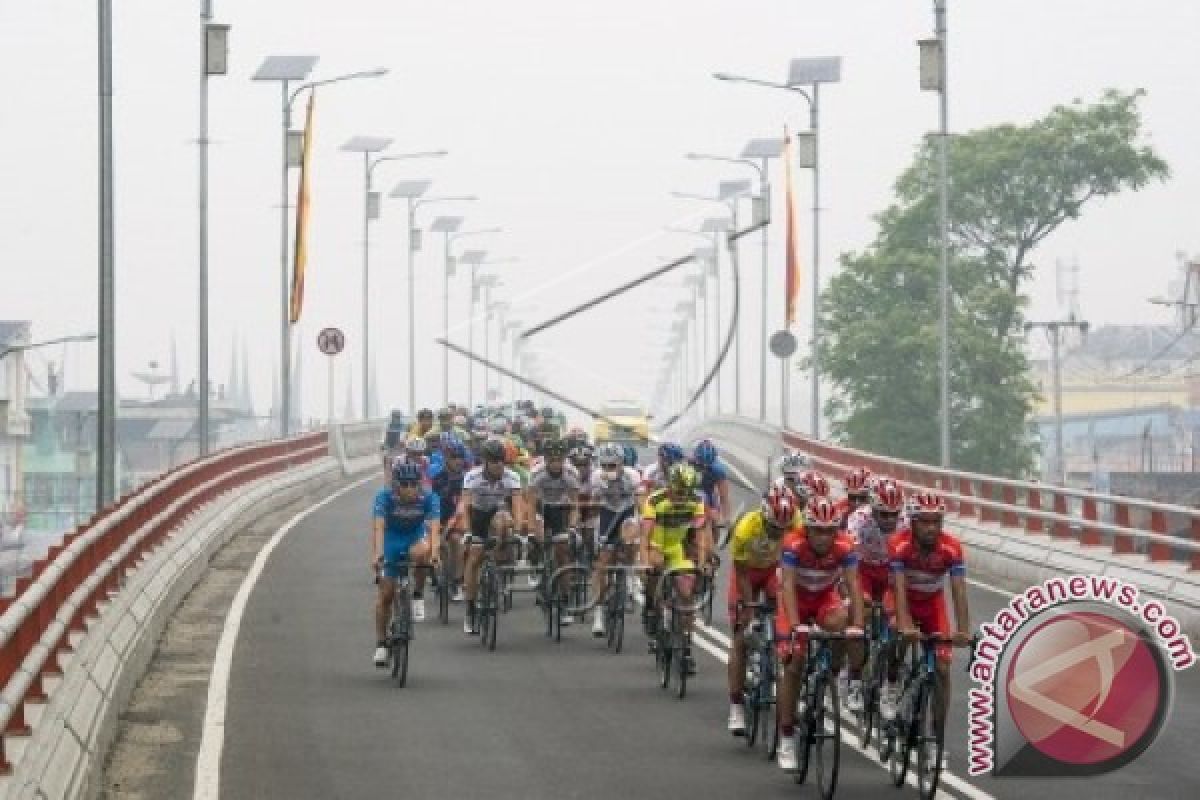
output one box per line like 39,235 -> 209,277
700,417 -> 1200,570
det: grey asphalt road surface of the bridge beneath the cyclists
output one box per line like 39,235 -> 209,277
211,486 -> 1200,800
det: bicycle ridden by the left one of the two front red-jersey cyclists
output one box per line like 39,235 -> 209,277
792,625 -> 862,800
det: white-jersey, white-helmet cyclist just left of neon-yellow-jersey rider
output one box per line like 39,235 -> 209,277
587,443 -> 642,637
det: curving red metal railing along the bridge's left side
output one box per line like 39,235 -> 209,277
0,432 -> 330,774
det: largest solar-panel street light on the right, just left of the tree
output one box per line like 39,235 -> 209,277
713,56 -> 841,439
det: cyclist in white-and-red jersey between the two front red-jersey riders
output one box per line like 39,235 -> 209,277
846,479 -> 904,712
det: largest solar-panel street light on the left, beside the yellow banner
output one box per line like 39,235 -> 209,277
253,55 -> 388,437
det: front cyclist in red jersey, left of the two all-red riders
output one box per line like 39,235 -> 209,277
776,497 -> 863,771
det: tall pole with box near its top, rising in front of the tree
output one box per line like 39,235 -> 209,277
917,0 -> 950,468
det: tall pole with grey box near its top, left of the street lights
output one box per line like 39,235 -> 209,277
197,0 -> 229,456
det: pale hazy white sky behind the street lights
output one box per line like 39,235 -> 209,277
0,0 -> 1200,429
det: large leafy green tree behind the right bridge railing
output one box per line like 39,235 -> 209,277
821,90 -> 1169,475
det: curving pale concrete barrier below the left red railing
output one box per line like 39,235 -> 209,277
0,426 -> 382,800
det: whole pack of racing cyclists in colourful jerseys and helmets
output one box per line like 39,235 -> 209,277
371,403 -> 970,770
